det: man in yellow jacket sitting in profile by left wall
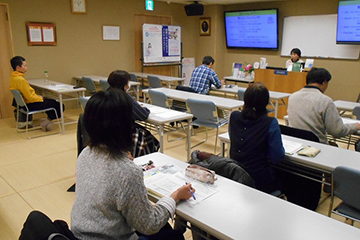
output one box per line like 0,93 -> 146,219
10,56 -> 65,131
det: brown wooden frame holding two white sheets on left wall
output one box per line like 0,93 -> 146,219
26,22 -> 57,46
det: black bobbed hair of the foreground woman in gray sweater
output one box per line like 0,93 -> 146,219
84,89 -> 133,158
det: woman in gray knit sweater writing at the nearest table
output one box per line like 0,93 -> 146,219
71,89 -> 195,240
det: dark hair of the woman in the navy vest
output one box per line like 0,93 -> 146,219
242,83 -> 269,119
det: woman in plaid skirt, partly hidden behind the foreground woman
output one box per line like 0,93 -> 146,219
108,70 -> 160,157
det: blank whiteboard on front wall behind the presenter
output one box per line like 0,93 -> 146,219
281,14 -> 360,59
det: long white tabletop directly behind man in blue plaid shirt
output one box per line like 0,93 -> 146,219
143,88 -> 244,111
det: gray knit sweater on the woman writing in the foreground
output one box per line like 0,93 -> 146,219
71,147 -> 176,240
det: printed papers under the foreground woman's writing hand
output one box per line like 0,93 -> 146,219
144,163 -> 218,204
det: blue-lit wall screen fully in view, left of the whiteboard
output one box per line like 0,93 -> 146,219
225,9 -> 279,50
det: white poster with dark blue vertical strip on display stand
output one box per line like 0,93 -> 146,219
143,23 -> 181,63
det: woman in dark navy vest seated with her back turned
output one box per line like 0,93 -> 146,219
229,83 -> 285,193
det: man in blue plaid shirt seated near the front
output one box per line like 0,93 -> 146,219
190,56 -> 224,94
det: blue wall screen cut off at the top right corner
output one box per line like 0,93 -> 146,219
336,0 -> 360,44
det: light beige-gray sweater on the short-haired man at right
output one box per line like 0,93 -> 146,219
288,87 -> 357,143
